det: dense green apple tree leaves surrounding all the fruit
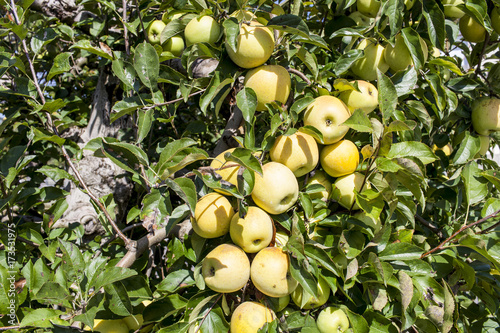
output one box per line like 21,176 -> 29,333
0,0 -> 500,333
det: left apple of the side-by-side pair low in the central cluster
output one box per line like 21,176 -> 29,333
201,244 -> 250,293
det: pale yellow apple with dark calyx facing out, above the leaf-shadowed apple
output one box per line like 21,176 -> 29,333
304,95 -> 351,145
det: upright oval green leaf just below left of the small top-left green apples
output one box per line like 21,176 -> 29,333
134,42 -> 160,91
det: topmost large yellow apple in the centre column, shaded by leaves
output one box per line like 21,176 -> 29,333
226,21 -> 274,68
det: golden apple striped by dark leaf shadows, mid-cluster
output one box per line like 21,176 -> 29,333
269,131 -> 319,177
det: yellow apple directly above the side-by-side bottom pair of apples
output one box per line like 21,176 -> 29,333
229,206 -> 274,253
